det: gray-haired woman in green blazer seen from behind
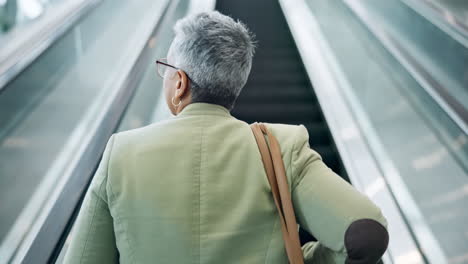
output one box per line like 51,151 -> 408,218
65,12 -> 388,263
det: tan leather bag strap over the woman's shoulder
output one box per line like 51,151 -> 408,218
250,123 -> 304,264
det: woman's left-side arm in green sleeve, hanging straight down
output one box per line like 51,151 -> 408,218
64,136 -> 118,264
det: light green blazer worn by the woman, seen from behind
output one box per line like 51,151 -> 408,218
65,103 -> 386,264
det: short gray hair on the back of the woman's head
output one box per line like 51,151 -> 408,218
168,11 -> 255,110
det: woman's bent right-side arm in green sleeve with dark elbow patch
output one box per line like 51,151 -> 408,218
291,126 -> 388,264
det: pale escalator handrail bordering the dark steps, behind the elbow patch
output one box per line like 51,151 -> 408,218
280,0 -> 432,263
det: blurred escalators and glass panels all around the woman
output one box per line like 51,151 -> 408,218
0,0 -> 468,264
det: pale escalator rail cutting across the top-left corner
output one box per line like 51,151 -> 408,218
0,0 -> 102,93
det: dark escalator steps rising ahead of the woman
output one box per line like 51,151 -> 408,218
216,0 -> 349,248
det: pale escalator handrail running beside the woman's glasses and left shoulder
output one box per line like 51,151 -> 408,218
3,0 -> 179,263
